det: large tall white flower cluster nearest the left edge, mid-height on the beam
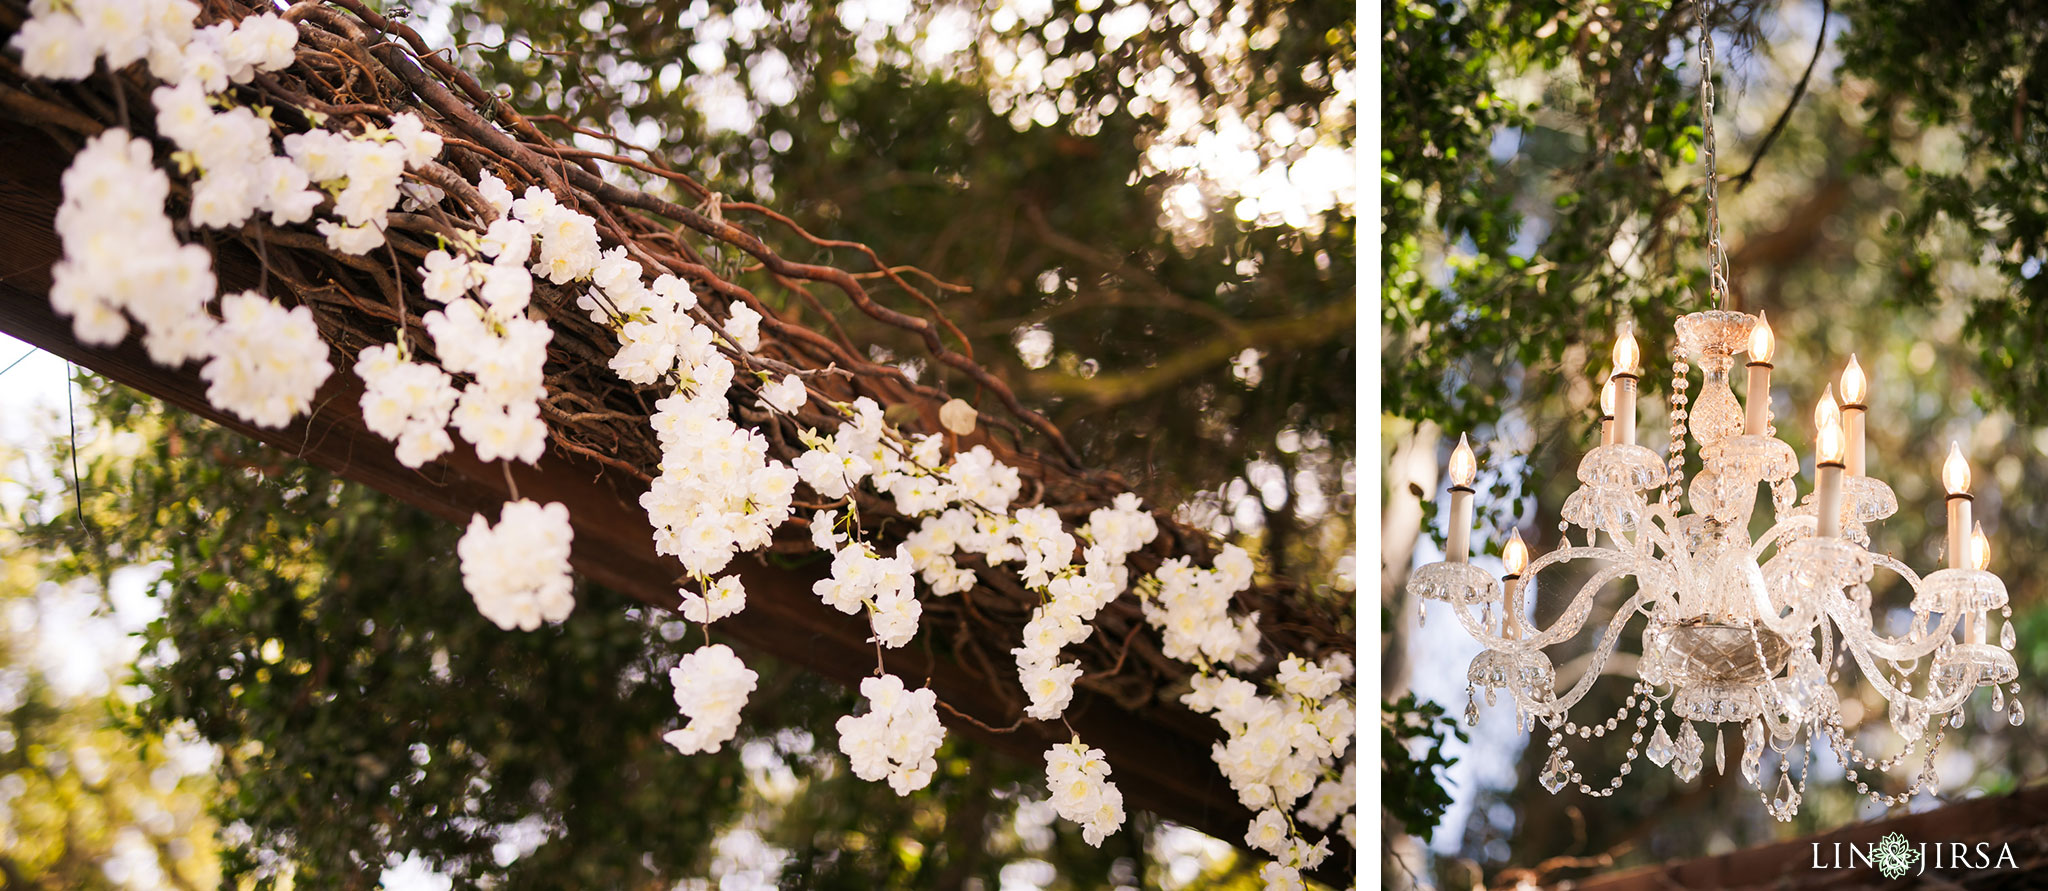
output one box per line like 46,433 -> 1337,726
49,129 -> 215,365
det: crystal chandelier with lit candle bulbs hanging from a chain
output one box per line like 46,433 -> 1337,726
1407,8 -> 2023,819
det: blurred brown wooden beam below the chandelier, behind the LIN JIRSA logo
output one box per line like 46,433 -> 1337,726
1548,787 -> 2048,891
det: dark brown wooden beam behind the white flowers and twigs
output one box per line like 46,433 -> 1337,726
0,109 -> 1269,856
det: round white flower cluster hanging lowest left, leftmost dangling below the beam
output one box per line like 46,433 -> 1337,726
455,500 -> 575,631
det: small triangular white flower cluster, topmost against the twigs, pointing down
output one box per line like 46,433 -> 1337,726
285,113 -> 442,254
